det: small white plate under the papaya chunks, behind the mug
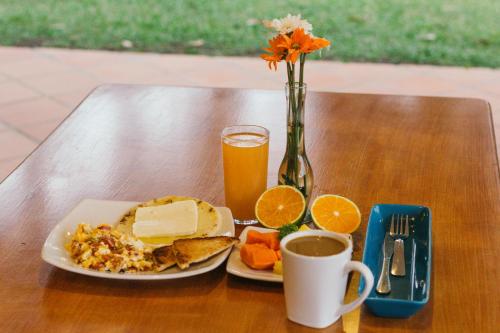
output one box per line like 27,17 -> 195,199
226,226 -> 283,282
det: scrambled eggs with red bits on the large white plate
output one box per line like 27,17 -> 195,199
66,223 -> 156,273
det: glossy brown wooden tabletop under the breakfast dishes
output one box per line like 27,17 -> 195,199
0,85 -> 500,332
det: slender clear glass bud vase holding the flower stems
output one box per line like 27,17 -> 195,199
278,83 -> 314,203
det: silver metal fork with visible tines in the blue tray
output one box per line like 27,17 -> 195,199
389,214 -> 410,276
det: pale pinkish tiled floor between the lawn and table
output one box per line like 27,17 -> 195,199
0,47 -> 500,180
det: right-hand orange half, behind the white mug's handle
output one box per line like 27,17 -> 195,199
311,194 -> 361,234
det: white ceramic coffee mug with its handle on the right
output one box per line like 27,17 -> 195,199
280,230 -> 373,328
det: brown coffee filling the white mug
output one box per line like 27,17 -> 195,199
286,236 -> 346,257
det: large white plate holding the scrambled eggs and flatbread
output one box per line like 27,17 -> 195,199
42,199 -> 234,280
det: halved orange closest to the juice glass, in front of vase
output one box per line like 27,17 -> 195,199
255,185 -> 306,229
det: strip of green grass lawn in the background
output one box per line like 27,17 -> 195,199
0,0 -> 500,67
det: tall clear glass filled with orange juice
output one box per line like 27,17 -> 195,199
222,125 -> 269,225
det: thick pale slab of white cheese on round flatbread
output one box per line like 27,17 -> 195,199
132,200 -> 198,237
